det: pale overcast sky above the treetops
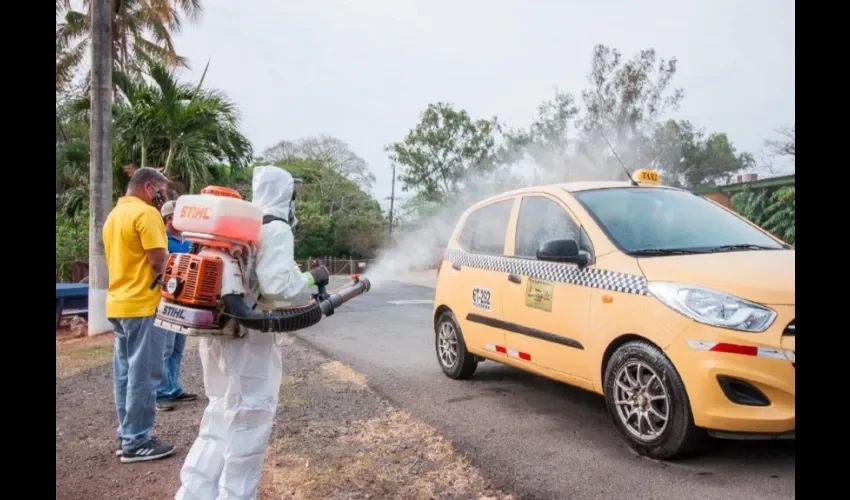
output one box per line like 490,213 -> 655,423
175,0 -> 795,205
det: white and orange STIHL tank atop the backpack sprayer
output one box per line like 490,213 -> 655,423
174,186 -> 263,243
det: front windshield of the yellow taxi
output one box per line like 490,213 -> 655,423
575,187 -> 786,255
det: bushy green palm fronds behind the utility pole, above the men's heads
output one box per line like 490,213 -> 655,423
56,64 -> 252,216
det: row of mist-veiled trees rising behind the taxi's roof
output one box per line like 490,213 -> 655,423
387,45 -> 756,201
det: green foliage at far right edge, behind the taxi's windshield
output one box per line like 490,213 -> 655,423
732,186 -> 797,245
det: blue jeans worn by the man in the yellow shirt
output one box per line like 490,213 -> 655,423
109,316 -> 165,451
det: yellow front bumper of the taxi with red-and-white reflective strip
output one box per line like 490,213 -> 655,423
666,320 -> 796,435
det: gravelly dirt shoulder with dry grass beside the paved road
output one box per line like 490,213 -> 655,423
56,336 -> 511,500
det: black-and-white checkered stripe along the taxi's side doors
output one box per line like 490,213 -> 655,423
445,250 -> 648,295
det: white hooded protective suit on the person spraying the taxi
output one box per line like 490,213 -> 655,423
175,166 -> 327,500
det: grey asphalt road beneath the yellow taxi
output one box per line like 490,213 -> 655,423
294,282 -> 795,500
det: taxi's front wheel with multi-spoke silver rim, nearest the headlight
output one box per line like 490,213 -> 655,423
605,341 -> 703,460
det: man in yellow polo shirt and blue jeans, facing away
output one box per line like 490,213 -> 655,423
103,167 -> 174,463
